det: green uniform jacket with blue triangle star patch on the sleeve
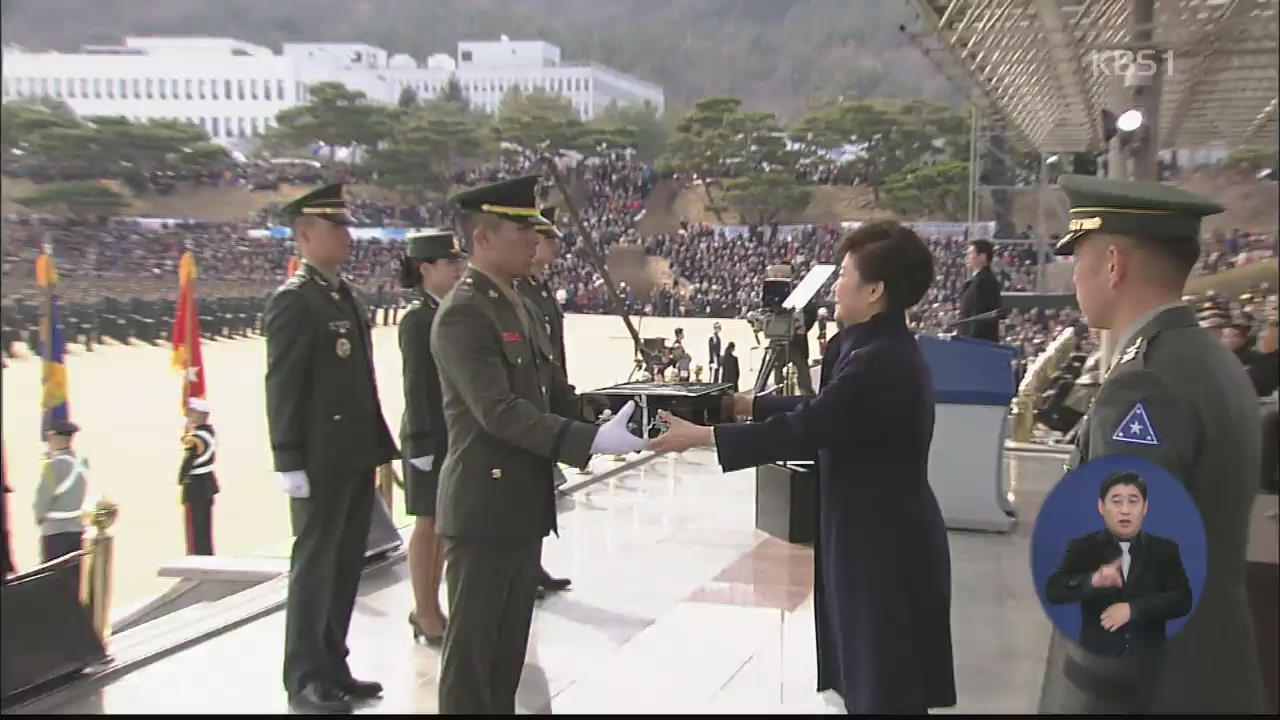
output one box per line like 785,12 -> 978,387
1041,305 -> 1266,714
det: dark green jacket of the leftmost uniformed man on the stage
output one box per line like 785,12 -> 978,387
262,263 -> 399,483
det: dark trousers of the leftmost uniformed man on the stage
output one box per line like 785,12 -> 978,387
284,469 -> 374,694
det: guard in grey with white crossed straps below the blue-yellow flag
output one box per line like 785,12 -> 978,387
35,420 -> 88,562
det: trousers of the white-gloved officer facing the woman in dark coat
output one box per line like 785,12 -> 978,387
439,537 -> 543,715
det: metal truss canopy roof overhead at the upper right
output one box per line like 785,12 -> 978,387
911,0 -> 1280,152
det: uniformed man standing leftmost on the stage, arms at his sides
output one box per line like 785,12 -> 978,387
262,183 -> 399,712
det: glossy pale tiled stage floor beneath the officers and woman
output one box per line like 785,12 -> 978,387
10,452 -> 1062,714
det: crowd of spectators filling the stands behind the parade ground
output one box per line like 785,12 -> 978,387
3,155 -> 1276,379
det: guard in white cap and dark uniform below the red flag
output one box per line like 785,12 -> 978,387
178,397 -> 218,555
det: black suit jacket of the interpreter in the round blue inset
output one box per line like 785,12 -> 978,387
1044,530 -> 1192,657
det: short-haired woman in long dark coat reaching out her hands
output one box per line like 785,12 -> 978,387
650,222 -> 956,712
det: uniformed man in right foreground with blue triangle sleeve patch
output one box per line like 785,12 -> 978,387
1041,176 -> 1265,714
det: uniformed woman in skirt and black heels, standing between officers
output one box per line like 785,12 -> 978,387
399,231 -> 466,646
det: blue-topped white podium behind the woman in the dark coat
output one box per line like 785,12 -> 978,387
918,336 -> 1018,533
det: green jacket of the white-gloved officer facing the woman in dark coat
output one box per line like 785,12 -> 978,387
431,268 -> 596,541
